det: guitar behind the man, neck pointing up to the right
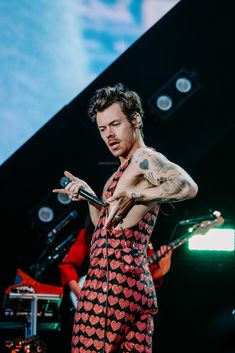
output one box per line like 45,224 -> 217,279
69,213 -> 224,309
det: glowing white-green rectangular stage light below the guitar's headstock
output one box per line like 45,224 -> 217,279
188,228 -> 235,251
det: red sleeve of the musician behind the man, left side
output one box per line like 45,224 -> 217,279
58,228 -> 90,286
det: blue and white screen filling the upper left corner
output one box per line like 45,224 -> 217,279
0,0 -> 179,164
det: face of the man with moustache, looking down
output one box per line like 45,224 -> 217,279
96,103 -> 137,158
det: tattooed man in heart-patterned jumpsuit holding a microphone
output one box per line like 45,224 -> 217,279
54,84 -> 198,353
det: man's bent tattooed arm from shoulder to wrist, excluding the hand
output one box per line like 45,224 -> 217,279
132,149 -> 198,202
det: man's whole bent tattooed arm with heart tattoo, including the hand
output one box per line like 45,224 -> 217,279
103,147 -> 198,227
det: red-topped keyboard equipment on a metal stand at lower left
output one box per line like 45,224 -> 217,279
0,269 -> 63,338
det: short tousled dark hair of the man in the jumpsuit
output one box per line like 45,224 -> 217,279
88,83 -> 144,135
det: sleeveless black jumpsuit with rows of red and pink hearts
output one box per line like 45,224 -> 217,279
71,159 -> 159,353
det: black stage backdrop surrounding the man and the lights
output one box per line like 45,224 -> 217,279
0,0 -> 235,353
